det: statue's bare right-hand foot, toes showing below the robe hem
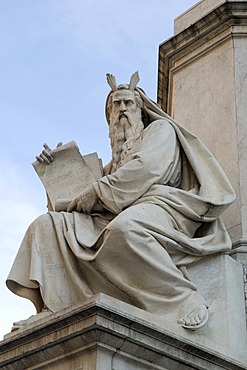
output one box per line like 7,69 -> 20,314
178,304 -> 209,330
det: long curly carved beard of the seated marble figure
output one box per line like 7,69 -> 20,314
109,112 -> 144,173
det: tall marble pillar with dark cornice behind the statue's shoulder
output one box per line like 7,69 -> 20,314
158,0 -> 247,265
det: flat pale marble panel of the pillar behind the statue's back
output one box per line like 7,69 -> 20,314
172,34 -> 239,240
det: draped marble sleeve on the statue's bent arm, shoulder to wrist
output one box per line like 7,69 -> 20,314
94,120 -> 179,214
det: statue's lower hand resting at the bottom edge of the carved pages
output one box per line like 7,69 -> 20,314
67,185 -> 98,213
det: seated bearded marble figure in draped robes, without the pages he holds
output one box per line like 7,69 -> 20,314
7,73 -> 235,330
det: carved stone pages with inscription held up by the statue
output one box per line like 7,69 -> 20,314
32,141 -> 103,211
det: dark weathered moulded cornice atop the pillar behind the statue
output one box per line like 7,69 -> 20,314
158,1 -> 247,114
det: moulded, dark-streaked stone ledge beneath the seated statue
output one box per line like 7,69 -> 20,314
0,294 -> 246,370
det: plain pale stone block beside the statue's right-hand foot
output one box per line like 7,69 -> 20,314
189,255 -> 247,352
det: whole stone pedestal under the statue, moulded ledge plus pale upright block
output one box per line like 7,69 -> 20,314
0,255 -> 247,370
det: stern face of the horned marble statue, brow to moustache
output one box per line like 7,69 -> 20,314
111,90 -> 141,120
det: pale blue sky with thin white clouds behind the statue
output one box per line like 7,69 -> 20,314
0,0 -> 198,340
